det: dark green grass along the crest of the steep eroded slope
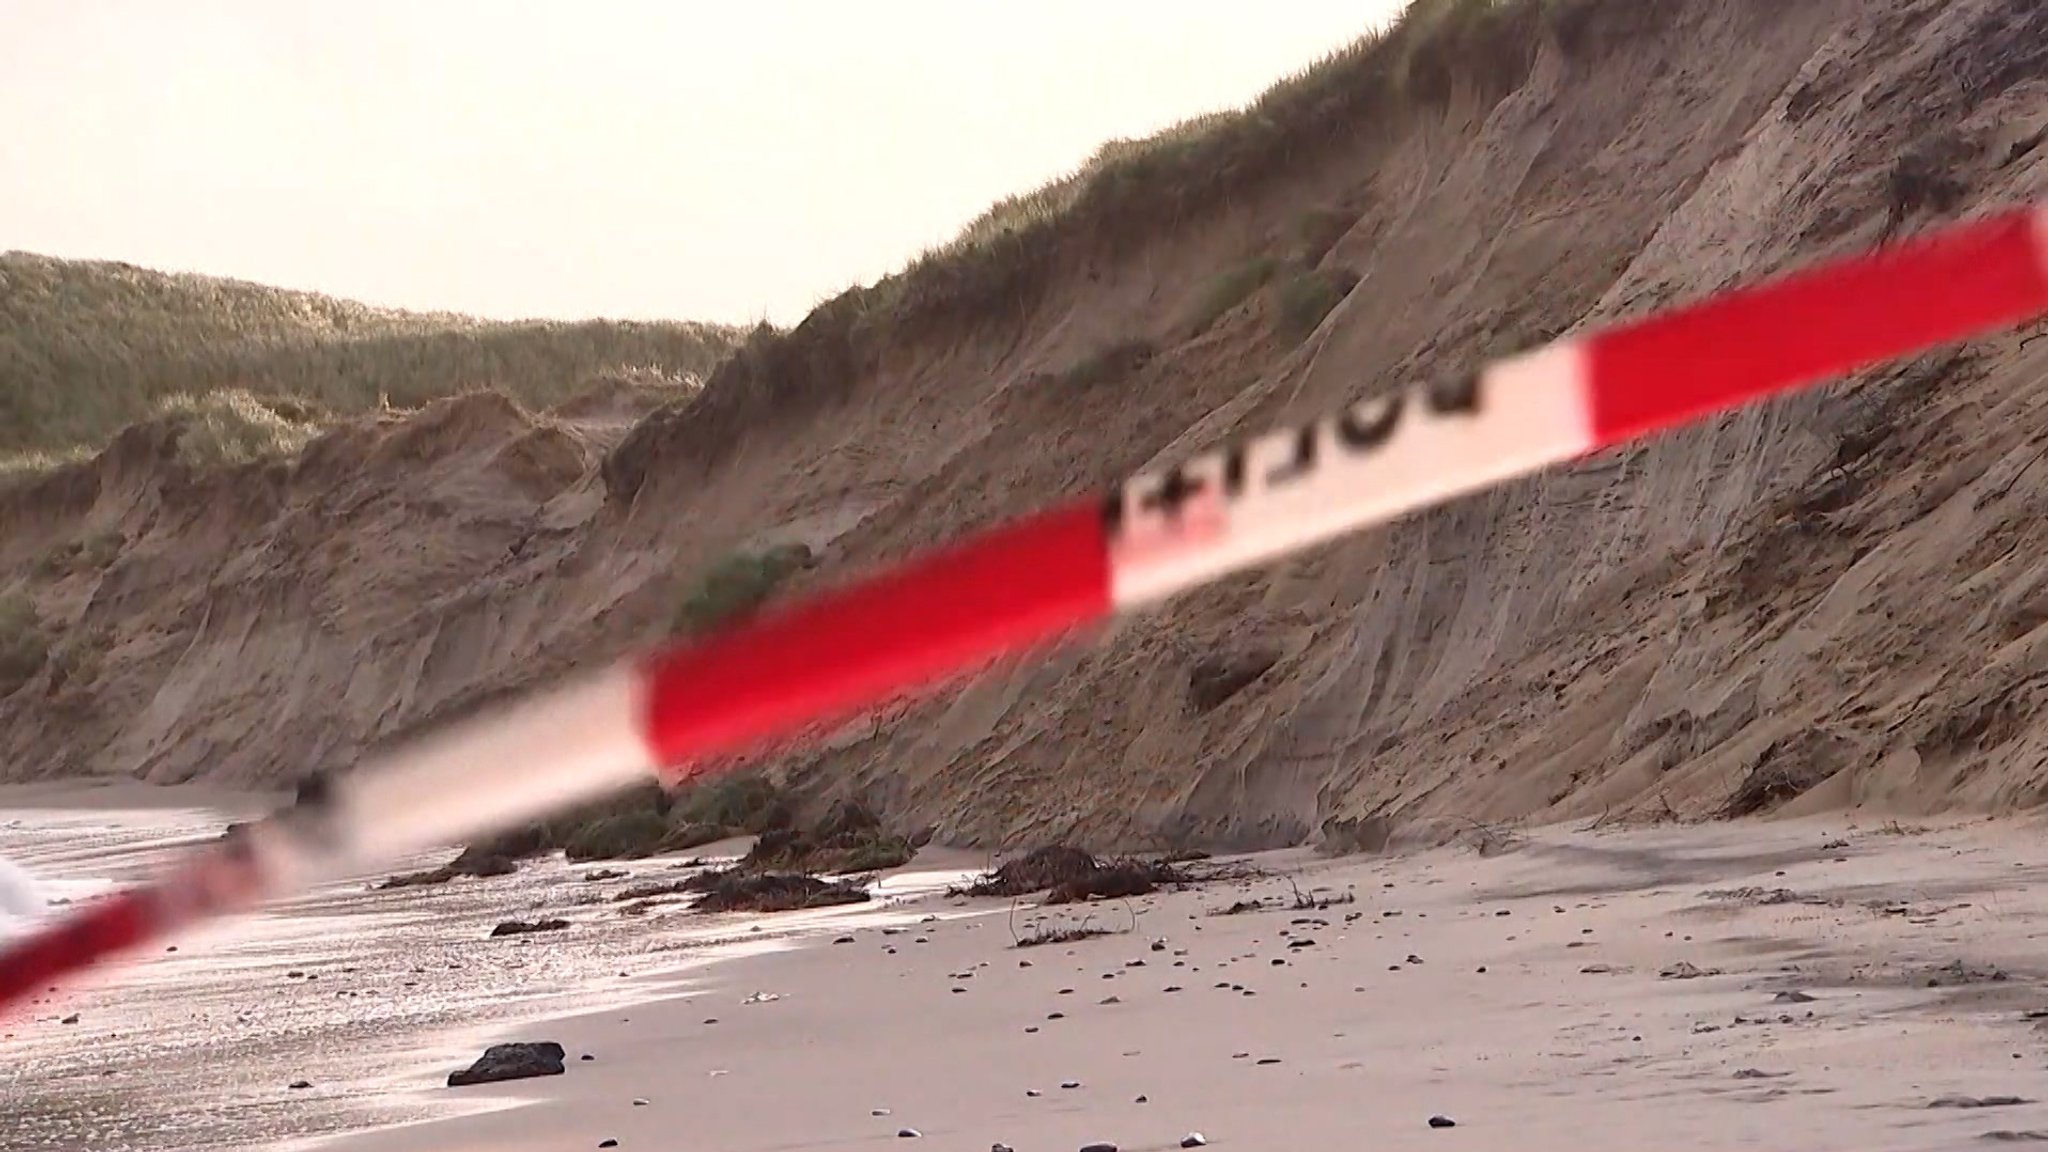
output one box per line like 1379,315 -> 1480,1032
638,0 -> 1597,494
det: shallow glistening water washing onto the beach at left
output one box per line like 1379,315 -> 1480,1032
0,810 -> 958,1152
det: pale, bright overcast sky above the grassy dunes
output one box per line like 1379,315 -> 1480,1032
0,0 -> 1403,324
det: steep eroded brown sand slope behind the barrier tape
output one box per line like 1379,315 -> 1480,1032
0,0 -> 2048,847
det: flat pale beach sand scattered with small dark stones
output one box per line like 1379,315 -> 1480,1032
330,818 -> 2048,1152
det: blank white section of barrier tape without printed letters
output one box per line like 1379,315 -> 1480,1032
330,662 -> 657,871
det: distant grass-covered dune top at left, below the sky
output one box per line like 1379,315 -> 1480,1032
0,252 -> 739,461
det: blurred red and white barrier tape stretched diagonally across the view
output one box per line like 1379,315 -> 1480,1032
0,207 -> 2048,1011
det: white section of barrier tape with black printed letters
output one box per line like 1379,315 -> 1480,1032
1110,340 -> 1595,609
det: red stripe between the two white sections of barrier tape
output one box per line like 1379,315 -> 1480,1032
645,500 -> 1110,765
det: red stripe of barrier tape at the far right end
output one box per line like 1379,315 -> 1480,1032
1587,211 -> 2048,447
